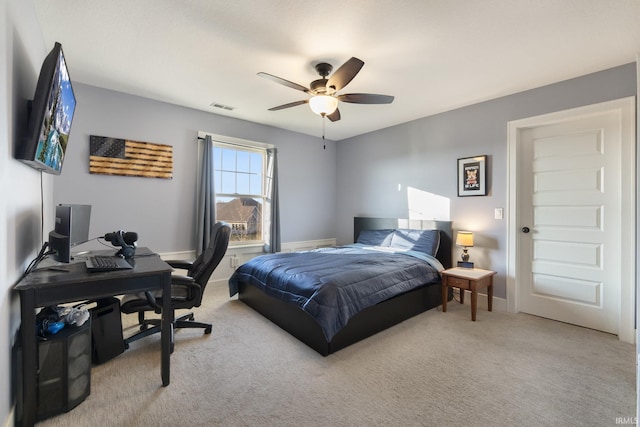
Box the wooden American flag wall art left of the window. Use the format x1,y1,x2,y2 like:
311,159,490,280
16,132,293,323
89,135,173,179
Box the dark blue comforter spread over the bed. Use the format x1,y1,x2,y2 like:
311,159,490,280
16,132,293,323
229,244,443,342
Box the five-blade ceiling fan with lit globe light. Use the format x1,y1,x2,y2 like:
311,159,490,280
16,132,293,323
258,57,393,122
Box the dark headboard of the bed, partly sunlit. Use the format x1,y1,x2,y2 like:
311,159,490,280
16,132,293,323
353,216,453,268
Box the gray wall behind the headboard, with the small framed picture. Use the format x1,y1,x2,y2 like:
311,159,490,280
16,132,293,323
336,63,636,298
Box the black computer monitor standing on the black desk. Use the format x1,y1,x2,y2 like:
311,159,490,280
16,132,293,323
49,205,91,262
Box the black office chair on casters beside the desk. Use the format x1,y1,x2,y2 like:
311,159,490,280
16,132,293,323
120,222,231,351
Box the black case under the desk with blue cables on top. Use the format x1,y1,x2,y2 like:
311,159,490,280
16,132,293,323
37,321,91,420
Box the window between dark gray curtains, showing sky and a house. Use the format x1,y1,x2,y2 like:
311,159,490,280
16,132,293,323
213,141,266,244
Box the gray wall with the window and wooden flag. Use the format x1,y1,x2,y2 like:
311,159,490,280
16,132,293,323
53,83,336,252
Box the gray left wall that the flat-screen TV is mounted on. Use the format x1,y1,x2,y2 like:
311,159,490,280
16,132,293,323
0,0,60,426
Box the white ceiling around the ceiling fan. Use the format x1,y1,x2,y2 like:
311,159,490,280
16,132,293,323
34,0,640,141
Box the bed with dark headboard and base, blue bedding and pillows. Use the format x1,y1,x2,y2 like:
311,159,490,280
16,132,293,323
229,217,452,356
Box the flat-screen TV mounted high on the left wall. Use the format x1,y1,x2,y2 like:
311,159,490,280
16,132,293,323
16,43,76,175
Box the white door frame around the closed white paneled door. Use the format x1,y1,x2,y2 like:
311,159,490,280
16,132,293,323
507,96,636,343
